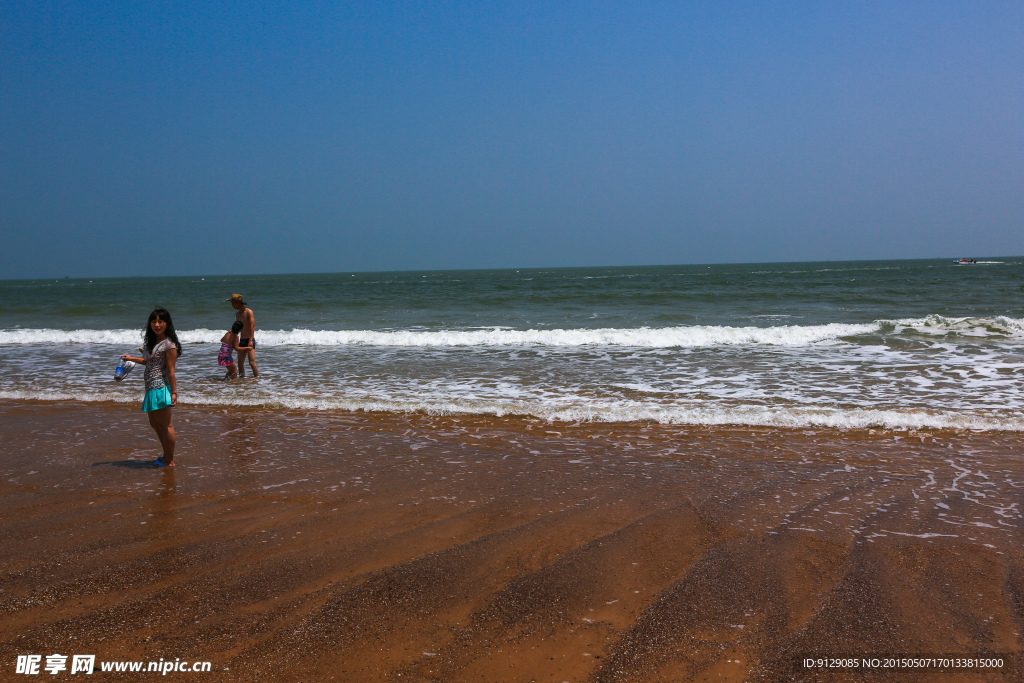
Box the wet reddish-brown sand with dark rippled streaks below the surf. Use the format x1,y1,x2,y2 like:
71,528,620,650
0,400,1024,682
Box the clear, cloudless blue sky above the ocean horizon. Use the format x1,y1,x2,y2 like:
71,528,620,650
0,0,1024,278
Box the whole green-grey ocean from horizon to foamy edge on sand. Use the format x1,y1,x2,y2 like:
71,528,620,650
0,257,1024,431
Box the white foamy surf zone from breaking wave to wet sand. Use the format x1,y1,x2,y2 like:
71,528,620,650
6,315,1024,431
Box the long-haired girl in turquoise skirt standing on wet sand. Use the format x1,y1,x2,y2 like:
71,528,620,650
121,306,181,467
